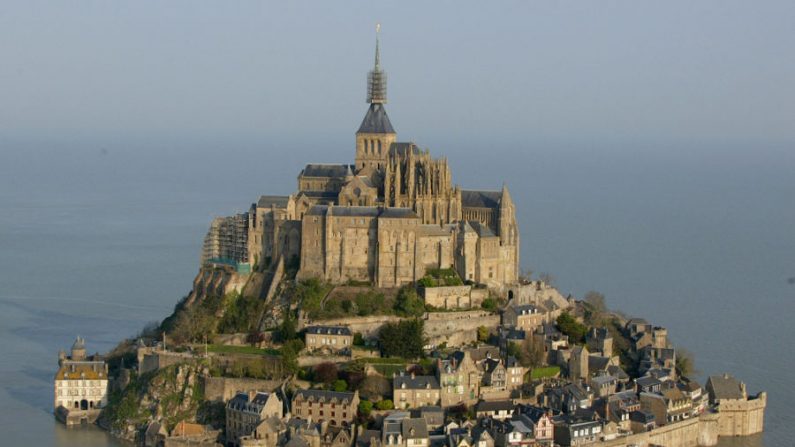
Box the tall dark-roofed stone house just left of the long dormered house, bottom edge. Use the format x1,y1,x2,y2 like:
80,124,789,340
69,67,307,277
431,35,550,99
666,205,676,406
226,392,283,446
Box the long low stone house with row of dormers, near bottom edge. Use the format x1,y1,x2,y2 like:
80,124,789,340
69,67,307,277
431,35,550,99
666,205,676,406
292,390,359,427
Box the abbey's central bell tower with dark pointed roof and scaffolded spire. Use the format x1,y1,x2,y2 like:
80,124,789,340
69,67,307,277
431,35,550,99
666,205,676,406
356,24,397,177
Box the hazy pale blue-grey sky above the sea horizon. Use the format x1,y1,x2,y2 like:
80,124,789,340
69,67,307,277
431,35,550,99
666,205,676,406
0,0,795,149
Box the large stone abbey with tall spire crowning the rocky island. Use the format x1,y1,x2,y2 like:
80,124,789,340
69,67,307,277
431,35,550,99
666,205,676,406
202,33,519,288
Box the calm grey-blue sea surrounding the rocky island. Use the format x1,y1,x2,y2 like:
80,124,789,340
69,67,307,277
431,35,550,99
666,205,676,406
0,137,795,447
